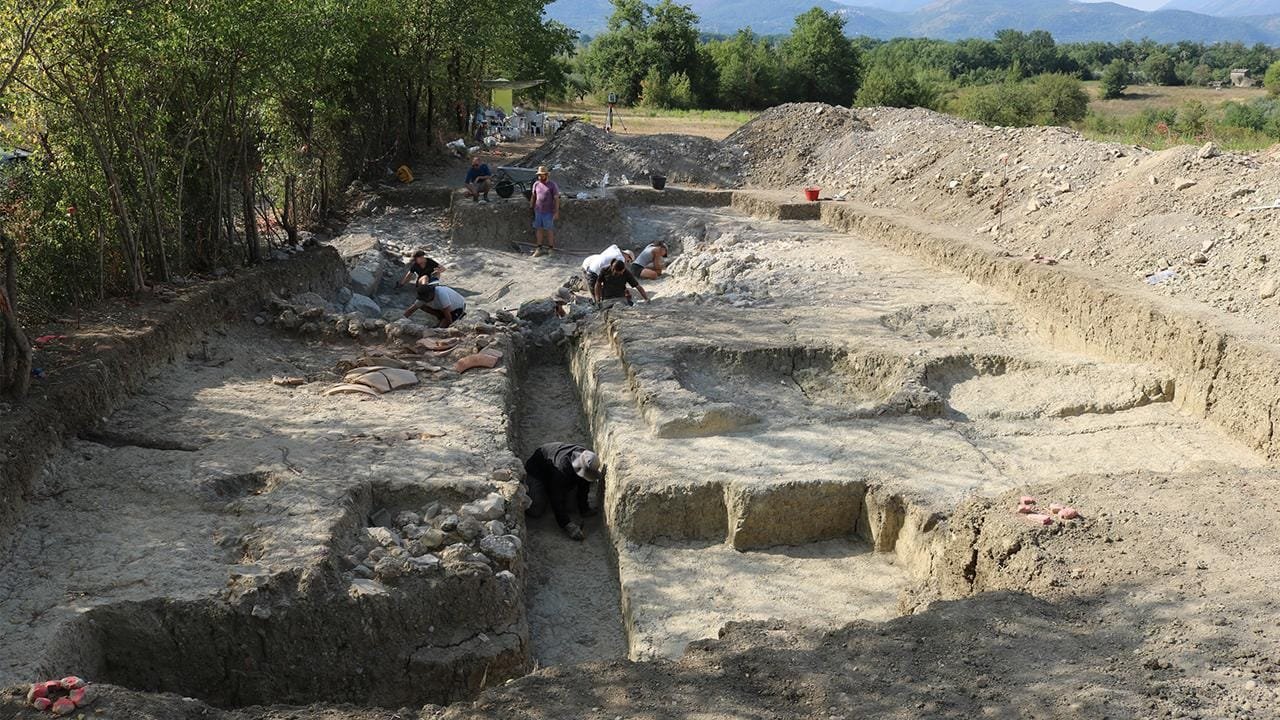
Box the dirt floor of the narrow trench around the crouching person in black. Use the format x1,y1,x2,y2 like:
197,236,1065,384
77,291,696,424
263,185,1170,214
520,364,627,667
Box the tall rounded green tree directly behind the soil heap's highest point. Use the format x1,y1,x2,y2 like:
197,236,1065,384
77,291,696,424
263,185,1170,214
780,8,861,105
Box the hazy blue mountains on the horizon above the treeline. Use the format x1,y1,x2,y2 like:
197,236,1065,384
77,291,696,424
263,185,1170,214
547,0,1280,45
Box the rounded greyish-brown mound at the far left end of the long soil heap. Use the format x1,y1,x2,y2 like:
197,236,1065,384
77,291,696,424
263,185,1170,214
722,102,869,187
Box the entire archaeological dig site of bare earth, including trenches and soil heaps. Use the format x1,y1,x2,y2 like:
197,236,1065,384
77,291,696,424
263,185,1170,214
0,104,1280,720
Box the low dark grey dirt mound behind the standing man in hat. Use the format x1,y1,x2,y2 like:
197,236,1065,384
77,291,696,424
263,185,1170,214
520,122,737,190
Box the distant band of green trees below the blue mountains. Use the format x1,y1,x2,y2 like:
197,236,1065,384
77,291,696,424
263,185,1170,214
566,0,1280,110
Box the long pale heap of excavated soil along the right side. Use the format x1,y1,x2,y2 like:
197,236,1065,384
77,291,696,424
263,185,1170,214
742,105,1280,328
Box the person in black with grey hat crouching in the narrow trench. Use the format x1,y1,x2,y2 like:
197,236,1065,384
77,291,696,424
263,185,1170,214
525,442,604,541
